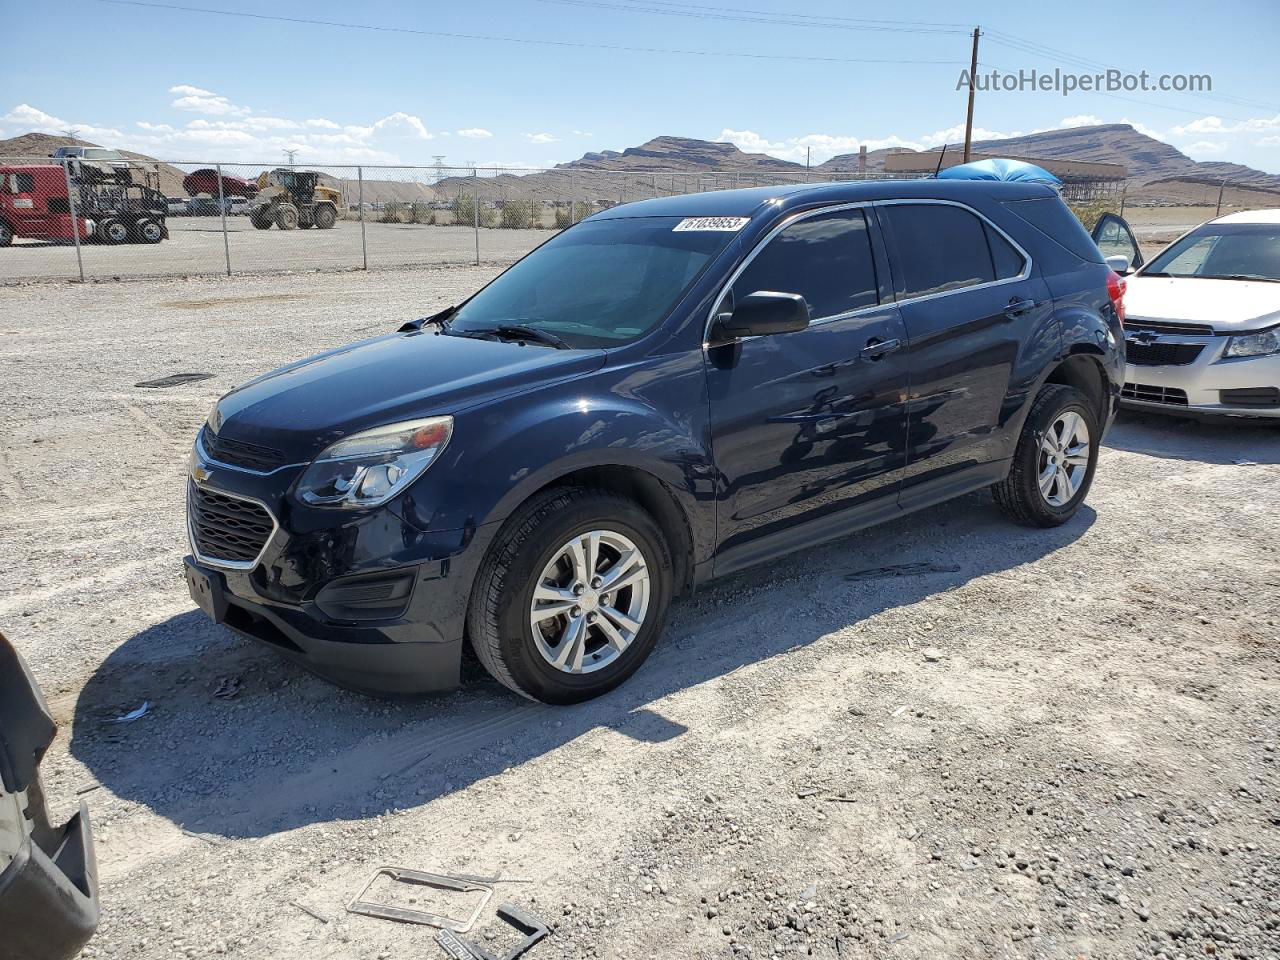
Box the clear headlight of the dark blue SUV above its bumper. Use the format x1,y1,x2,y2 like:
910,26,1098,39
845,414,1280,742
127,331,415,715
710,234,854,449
296,417,453,507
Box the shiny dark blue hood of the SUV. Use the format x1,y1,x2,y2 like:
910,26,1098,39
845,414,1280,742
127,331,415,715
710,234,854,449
211,332,604,462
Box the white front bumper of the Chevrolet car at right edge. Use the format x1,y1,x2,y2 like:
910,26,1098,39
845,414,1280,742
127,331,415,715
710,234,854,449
1120,337,1280,417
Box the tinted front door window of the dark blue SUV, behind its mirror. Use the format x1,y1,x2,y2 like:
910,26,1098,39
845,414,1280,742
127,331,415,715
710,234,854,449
733,210,879,320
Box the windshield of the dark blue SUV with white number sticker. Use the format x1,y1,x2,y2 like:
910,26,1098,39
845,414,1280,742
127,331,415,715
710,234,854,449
449,216,733,347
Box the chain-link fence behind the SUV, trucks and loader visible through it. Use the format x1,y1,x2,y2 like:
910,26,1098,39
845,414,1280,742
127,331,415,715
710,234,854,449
0,151,1280,283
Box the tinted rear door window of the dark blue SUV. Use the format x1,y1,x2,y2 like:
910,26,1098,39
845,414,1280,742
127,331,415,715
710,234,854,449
881,204,993,300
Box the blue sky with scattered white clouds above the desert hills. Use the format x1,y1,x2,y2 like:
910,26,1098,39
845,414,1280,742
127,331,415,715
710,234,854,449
0,0,1280,173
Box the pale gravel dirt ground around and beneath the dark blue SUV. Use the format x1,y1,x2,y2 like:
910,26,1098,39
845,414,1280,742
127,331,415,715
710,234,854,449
0,268,1280,960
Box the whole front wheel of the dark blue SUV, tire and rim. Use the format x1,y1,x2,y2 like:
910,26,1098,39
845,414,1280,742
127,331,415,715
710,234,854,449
467,488,672,704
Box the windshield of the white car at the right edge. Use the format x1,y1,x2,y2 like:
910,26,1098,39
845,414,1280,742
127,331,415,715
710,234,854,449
1138,224,1280,283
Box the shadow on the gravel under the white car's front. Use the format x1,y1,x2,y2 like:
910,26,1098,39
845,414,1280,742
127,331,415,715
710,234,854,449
1103,410,1280,465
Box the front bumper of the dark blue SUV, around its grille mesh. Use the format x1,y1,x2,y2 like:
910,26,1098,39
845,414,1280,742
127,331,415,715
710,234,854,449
184,462,497,694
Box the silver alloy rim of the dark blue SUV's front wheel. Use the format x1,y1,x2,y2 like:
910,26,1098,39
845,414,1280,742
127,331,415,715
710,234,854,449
529,530,650,673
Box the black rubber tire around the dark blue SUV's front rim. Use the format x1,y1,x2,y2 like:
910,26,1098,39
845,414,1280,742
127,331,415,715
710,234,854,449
467,486,672,704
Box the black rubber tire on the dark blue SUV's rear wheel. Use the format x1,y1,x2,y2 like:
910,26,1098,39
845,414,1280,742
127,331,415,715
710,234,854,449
992,384,1102,527
